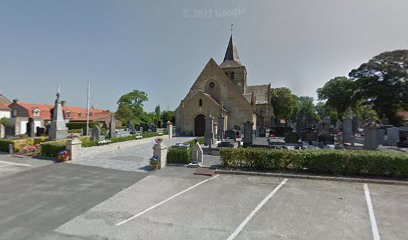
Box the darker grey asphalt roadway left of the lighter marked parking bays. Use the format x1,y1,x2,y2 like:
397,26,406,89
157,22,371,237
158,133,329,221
0,155,146,240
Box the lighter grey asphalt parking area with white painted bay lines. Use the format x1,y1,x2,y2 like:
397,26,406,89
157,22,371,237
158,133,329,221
42,167,408,240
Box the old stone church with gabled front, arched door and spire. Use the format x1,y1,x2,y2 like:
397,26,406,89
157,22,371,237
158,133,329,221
176,34,273,136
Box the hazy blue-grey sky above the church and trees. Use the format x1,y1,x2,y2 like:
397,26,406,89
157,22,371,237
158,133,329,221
0,0,408,111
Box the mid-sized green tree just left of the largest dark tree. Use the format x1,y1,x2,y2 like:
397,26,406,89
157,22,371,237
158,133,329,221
317,77,355,118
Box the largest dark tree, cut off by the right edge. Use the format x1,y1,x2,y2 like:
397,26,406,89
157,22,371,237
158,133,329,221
349,50,408,124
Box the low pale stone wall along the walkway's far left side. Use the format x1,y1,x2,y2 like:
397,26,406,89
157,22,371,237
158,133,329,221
72,135,168,161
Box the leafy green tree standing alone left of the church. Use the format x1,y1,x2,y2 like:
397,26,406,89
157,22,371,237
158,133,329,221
116,90,149,125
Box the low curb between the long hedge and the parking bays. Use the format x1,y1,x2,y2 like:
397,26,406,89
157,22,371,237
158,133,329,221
215,169,408,186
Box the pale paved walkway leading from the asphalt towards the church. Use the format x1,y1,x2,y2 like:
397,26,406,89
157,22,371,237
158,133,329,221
71,137,194,172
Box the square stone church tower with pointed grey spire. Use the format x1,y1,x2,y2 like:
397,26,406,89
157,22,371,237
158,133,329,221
220,32,247,94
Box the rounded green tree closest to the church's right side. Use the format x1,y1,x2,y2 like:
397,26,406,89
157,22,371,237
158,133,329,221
271,87,297,119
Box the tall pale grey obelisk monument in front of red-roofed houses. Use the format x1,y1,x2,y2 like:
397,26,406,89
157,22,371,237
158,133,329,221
48,89,68,140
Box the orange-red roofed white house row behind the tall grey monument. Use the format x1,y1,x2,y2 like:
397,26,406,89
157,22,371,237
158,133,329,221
8,99,111,135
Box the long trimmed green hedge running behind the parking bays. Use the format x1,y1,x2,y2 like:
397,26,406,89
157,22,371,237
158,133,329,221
221,148,408,178
